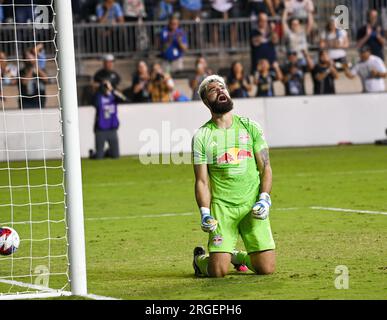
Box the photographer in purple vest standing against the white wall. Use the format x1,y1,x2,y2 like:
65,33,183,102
90,80,122,159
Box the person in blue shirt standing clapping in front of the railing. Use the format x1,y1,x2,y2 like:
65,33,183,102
161,16,188,72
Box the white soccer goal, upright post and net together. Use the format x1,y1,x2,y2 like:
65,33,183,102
0,0,88,300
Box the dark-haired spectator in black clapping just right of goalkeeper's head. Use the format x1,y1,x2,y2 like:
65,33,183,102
227,61,253,98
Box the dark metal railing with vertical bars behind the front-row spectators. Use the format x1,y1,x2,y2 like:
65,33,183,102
0,18,336,59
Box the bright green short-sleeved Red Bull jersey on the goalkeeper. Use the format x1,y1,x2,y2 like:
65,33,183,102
192,115,268,207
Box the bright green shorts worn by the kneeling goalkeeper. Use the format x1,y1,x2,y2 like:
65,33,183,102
208,203,275,253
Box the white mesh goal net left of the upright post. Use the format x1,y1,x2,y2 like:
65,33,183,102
0,0,83,299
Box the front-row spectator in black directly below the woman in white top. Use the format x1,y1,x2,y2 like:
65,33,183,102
304,49,339,94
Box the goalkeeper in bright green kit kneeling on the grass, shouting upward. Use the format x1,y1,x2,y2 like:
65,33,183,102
192,75,275,277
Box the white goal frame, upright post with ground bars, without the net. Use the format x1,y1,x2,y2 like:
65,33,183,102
0,0,87,300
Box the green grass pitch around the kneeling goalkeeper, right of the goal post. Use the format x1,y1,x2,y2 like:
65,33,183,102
0,145,387,300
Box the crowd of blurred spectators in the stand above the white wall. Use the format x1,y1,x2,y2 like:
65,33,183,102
0,0,387,108
